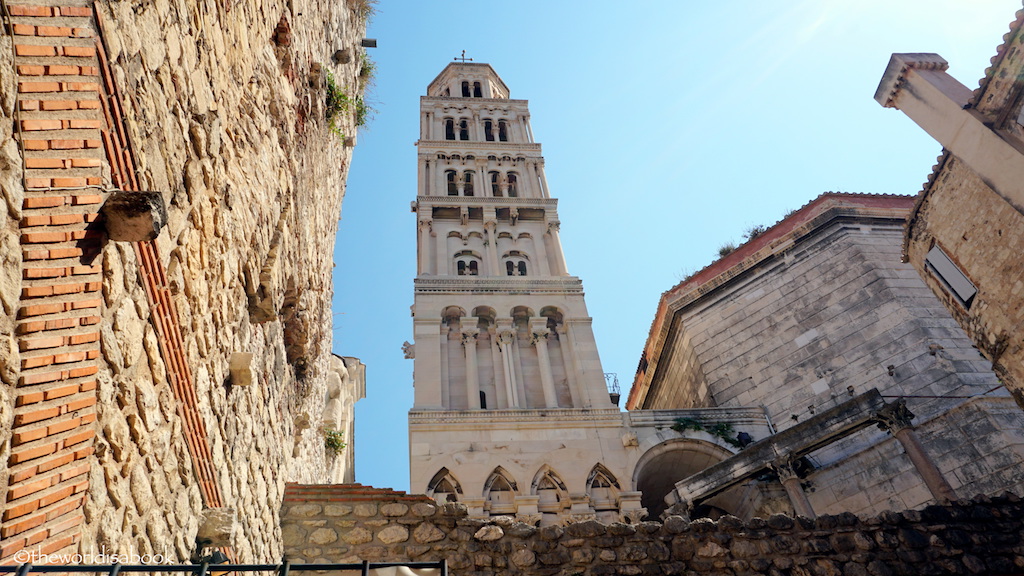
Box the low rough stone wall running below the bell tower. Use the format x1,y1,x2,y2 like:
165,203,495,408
282,479,1024,576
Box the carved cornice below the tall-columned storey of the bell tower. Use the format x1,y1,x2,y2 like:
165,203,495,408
409,408,623,426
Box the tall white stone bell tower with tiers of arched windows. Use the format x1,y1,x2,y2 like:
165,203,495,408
409,61,639,524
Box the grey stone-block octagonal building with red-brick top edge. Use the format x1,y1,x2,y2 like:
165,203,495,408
627,194,1024,517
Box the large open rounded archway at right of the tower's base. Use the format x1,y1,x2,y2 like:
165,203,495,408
633,438,733,520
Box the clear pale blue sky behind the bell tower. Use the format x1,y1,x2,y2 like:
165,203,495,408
334,0,1021,490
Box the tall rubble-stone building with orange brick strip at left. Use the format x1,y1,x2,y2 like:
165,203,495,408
0,0,369,564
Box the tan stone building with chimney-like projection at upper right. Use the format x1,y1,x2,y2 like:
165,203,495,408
874,11,1024,407
